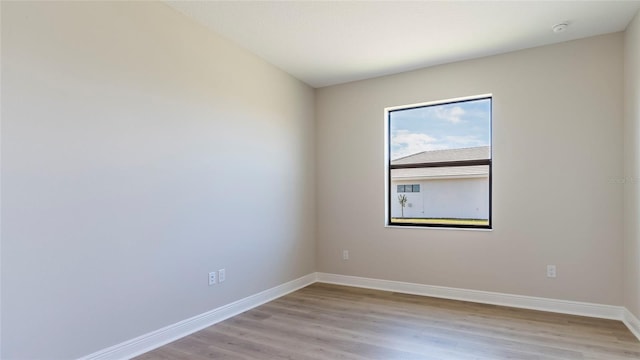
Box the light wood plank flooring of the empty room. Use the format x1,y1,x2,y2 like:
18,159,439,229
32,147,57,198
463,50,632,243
136,283,640,360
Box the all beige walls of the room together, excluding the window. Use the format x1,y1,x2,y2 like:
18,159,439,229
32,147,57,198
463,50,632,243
0,2,640,359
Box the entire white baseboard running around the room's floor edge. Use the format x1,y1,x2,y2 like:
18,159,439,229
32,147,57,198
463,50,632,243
79,273,640,360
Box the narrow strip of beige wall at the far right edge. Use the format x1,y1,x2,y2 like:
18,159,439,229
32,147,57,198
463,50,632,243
624,9,640,318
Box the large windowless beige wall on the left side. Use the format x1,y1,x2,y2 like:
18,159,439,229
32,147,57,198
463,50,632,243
0,2,315,359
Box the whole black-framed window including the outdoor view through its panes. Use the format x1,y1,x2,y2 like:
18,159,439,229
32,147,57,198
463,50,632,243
385,95,492,229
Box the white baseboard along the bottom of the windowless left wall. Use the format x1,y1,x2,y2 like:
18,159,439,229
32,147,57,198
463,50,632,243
80,273,316,360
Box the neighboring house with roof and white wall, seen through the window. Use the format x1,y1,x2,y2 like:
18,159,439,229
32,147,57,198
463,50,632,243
391,146,491,219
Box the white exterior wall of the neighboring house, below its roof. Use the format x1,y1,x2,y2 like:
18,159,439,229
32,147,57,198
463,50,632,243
391,177,489,219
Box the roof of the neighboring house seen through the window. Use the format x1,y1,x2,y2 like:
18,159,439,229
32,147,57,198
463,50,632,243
391,146,491,181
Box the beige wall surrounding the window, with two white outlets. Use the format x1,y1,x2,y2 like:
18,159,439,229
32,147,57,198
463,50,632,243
316,33,623,305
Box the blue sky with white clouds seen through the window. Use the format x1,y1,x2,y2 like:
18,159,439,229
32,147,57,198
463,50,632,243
389,99,491,160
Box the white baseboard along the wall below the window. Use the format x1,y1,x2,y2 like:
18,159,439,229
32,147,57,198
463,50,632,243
318,273,624,320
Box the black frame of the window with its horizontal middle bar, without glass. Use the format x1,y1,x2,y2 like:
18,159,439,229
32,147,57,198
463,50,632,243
385,94,493,230
